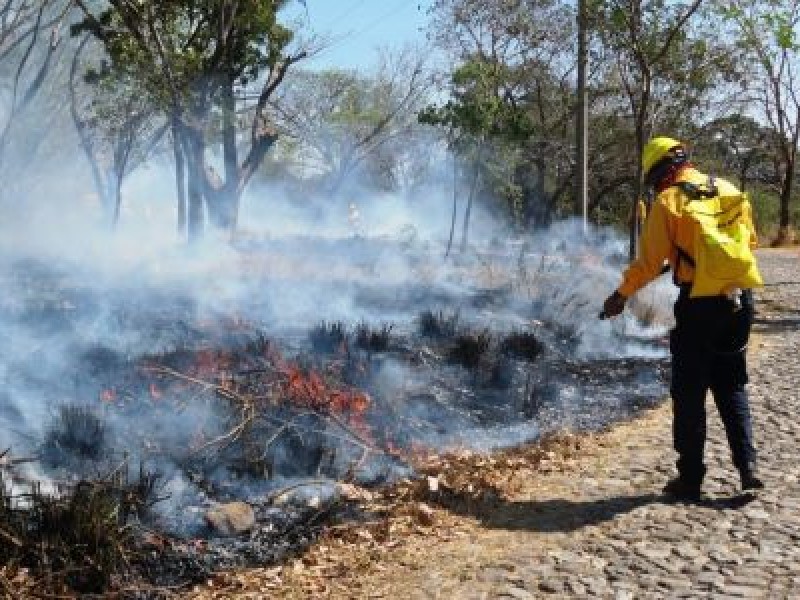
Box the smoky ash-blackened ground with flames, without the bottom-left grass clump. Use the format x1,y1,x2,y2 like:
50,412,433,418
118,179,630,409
0,231,669,596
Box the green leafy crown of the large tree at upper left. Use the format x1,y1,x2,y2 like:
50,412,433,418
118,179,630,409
72,0,292,109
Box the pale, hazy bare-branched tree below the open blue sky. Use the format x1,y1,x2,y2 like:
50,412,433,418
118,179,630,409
274,48,432,194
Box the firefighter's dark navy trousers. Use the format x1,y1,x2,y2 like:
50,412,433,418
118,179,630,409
670,289,756,483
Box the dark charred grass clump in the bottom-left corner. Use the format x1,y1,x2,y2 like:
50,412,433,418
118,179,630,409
0,462,162,597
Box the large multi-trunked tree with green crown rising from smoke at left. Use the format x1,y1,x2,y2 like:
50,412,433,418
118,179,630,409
75,0,306,239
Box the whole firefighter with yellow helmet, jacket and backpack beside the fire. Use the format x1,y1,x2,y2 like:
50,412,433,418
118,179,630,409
603,137,764,500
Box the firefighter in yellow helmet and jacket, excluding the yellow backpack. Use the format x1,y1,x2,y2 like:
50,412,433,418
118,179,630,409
603,137,764,500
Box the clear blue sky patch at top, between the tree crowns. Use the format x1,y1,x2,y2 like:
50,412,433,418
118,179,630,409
284,0,432,70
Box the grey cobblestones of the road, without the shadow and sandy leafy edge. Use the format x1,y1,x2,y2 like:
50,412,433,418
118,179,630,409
462,251,800,599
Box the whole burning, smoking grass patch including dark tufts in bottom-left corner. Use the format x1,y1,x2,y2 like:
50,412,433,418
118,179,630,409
0,229,664,598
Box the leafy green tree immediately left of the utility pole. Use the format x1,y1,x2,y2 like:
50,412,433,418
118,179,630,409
421,0,575,227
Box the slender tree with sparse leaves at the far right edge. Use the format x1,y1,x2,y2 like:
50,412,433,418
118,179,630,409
724,0,800,244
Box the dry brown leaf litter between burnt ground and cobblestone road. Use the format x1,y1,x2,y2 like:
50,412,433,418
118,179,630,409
192,433,604,600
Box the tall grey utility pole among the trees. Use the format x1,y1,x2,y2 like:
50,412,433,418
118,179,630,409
575,0,589,233
